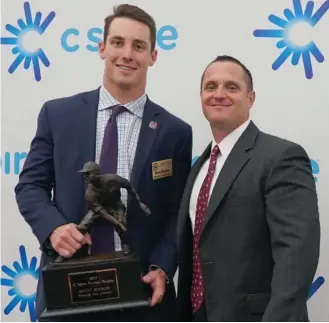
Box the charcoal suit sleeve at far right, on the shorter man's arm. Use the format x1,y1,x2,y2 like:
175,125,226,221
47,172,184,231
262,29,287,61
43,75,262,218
263,144,320,322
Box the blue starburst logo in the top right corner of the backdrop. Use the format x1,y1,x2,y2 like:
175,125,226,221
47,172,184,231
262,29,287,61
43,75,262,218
253,0,329,79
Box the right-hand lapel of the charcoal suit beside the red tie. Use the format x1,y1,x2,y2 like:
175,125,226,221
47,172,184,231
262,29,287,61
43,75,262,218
203,122,258,235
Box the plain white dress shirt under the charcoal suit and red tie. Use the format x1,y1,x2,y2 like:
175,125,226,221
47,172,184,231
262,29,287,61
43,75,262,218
190,119,250,232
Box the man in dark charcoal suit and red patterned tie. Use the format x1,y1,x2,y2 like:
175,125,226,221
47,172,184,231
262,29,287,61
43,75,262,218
177,56,320,322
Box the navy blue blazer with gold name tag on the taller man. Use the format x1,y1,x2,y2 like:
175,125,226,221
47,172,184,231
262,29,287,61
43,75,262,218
15,89,192,322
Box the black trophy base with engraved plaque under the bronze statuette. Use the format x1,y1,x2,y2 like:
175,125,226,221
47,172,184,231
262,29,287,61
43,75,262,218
41,252,149,319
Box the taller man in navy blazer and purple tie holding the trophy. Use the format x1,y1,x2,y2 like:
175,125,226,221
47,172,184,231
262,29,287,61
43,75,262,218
15,4,192,321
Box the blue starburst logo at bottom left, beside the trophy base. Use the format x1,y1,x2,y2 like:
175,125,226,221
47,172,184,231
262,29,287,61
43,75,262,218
1,246,39,322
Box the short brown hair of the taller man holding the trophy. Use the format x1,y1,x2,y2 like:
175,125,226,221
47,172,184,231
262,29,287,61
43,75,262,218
104,4,156,51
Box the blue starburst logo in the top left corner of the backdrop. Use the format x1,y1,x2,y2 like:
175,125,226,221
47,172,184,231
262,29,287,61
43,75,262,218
1,2,55,82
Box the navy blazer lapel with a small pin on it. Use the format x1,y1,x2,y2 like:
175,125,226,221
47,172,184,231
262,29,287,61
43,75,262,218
130,98,161,191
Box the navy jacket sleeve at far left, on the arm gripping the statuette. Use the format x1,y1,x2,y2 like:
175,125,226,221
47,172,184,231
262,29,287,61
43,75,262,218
15,103,67,251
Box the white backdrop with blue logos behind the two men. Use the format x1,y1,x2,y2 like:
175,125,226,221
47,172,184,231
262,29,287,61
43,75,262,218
1,0,329,321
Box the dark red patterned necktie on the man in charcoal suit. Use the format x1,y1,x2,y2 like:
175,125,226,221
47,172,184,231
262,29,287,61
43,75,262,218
191,145,219,313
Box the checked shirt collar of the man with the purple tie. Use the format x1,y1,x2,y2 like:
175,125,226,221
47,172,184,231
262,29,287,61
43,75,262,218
98,85,147,118
